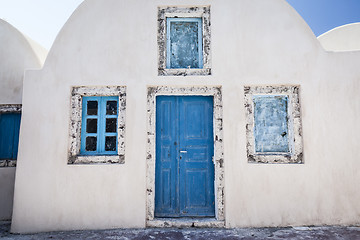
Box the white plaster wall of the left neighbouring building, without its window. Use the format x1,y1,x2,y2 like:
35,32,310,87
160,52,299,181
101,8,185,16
0,19,47,220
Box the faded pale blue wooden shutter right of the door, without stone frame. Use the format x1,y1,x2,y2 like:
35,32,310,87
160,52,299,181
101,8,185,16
253,95,289,153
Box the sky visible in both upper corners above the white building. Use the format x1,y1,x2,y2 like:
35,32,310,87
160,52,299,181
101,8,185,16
0,0,360,49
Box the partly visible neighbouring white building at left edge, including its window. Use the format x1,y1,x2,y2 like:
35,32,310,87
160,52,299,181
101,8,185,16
0,19,47,220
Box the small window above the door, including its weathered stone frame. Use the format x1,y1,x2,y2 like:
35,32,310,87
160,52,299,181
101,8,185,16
158,6,211,76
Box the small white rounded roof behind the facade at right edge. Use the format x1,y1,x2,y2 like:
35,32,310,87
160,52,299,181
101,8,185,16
318,23,360,51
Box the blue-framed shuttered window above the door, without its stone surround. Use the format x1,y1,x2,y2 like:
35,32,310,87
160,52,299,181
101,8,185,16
166,18,203,68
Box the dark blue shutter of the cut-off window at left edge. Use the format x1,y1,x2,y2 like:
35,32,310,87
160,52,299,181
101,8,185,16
0,113,21,160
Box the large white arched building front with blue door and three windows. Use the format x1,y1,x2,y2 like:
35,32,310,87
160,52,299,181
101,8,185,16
12,0,360,233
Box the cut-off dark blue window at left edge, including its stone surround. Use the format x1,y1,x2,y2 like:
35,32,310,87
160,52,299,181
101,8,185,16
0,104,21,167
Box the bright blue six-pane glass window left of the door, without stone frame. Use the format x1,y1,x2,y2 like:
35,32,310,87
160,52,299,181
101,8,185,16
80,96,119,155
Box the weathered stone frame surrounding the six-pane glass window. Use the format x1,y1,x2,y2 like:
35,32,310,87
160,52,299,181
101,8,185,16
68,86,126,164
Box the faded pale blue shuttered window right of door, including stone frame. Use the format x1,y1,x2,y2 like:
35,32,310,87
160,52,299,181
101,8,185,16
244,86,303,163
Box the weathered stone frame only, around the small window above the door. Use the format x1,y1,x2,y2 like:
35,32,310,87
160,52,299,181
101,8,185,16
158,6,211,76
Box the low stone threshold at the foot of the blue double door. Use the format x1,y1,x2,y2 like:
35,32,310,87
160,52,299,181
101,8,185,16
146,218,225,228
